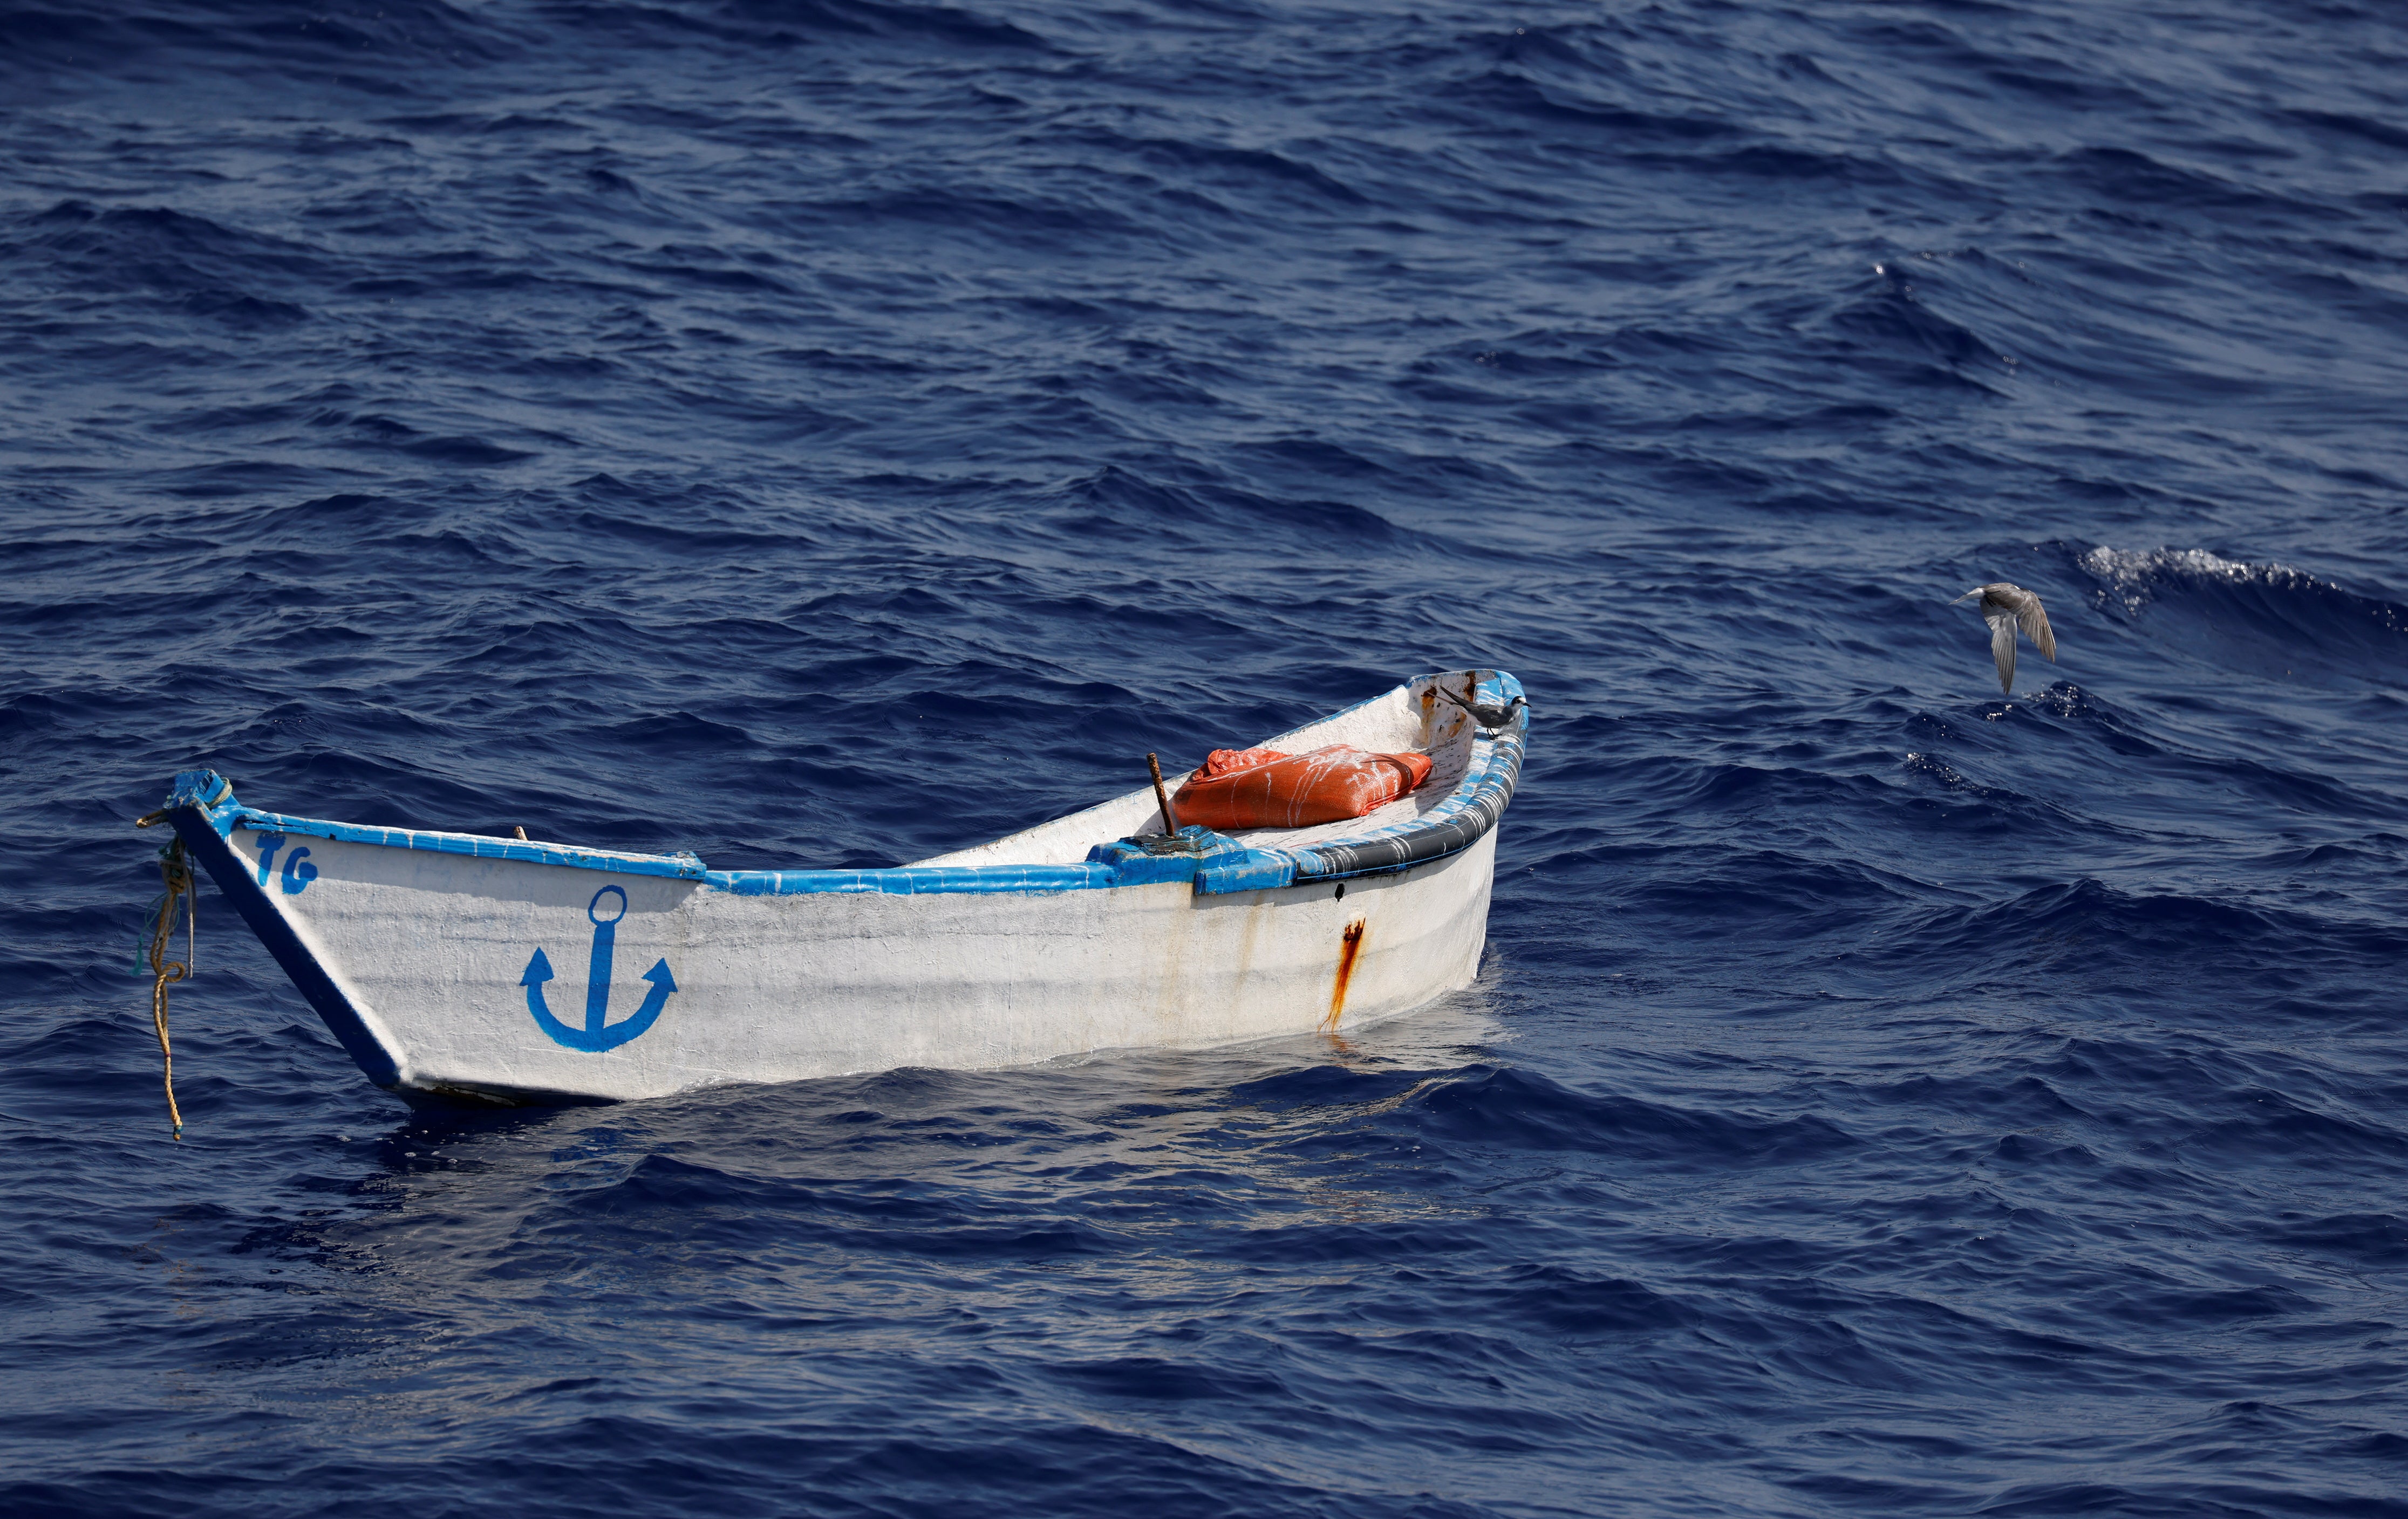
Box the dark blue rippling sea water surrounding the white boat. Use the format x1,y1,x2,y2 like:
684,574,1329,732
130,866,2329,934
0,0,2408,1519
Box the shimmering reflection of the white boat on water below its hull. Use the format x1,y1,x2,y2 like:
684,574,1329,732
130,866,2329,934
313,987,1505,1281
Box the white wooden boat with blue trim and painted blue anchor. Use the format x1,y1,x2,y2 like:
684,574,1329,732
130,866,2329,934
166,669,1529,1103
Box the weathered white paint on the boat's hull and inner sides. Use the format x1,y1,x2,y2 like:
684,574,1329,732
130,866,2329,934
165,681,1496,1100
